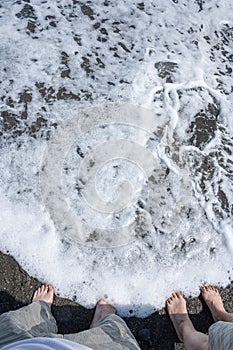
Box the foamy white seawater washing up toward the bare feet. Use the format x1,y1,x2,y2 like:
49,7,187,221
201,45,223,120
0,0,233,317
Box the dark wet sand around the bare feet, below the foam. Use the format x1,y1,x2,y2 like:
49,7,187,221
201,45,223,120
0,253,233,350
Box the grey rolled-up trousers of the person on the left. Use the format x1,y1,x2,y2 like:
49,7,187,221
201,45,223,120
0,301,140,350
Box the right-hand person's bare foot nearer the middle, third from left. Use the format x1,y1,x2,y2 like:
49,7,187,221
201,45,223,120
166,292,194,341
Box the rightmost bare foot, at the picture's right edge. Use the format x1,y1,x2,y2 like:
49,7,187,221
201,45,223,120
201,286,233,322
